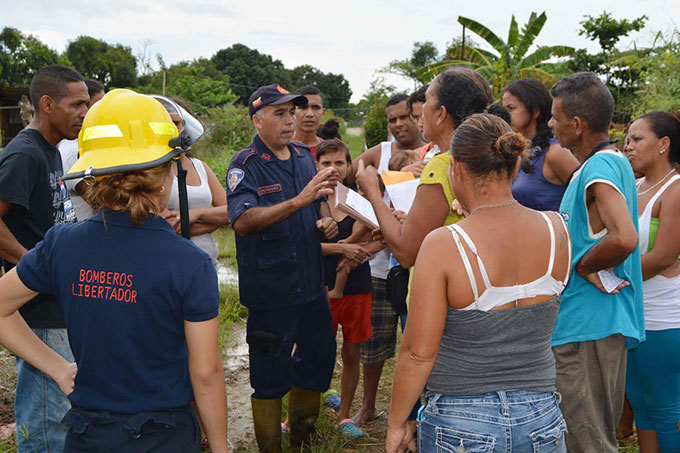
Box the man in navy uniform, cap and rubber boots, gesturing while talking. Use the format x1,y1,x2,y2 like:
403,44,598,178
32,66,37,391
226,85,337,452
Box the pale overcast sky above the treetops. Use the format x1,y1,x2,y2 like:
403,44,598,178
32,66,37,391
5,0,680,101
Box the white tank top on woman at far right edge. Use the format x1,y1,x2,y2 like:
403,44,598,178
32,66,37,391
637,175,680,330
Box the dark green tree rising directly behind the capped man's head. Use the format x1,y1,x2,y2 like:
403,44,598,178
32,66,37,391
210,44,290,105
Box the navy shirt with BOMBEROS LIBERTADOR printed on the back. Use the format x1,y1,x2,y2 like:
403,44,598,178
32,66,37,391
17,210,219,413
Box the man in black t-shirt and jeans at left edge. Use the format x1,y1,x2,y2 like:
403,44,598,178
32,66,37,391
0,65,90,453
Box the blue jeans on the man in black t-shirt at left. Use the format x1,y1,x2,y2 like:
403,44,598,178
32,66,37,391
14,329,73,453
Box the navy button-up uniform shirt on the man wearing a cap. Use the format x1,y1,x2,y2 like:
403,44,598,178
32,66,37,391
227,136,325,308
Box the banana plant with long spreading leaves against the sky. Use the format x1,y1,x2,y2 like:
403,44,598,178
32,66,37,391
417,12,574,98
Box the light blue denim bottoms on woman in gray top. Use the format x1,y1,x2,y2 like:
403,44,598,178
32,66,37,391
418,390,567,453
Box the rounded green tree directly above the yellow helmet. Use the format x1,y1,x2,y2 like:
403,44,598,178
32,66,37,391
66,36,137,88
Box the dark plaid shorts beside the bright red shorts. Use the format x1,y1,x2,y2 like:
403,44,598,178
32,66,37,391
360,277,399,365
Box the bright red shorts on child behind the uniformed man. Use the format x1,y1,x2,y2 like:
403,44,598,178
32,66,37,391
330,293,373,343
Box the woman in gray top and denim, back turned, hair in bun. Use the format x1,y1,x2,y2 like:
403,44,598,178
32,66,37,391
386,114,571,453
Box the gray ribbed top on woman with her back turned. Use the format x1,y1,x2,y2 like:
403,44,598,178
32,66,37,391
426,296,560,396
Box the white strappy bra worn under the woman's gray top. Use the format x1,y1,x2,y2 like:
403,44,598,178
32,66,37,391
447,212,571,311
